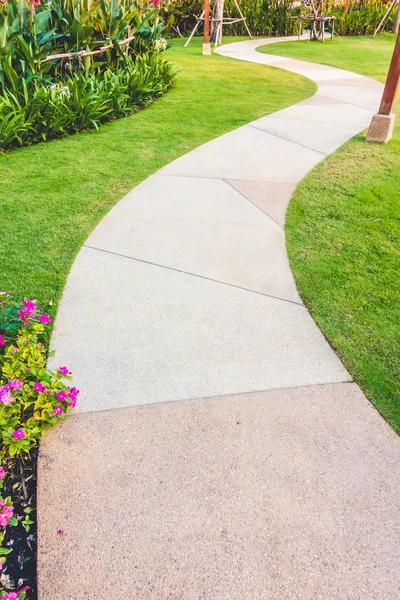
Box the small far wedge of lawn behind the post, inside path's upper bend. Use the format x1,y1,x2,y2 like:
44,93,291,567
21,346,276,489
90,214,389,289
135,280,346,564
258,33,396,81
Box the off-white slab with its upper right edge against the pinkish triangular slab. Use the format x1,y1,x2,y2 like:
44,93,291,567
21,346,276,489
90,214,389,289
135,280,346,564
86,175,301,303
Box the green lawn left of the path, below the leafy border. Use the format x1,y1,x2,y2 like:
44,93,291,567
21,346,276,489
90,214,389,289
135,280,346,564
0,38,315,314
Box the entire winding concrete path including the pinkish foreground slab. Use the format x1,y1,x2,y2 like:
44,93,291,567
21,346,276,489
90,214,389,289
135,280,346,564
39,39,400,600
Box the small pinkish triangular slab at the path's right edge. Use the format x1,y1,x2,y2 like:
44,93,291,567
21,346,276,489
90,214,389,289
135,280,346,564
228,179,296,227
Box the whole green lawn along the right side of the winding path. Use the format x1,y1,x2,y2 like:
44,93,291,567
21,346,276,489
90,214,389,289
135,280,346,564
265,34,400,433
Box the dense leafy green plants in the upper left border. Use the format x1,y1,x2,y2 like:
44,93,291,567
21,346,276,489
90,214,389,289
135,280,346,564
0,0,174,149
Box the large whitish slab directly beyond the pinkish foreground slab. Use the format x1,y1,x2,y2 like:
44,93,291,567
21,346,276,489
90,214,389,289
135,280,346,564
50,248,350,411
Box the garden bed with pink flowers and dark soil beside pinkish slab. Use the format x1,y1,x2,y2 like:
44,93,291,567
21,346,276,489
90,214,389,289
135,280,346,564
0,292,79,600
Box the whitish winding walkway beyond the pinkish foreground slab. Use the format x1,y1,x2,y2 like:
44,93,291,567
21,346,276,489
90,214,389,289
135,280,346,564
44,40,388,412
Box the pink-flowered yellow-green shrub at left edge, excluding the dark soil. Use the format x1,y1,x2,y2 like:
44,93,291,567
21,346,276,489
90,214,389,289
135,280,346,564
0,292,79,600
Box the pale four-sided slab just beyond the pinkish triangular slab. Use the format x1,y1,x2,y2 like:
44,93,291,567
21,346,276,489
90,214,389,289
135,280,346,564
159,125,324,183
